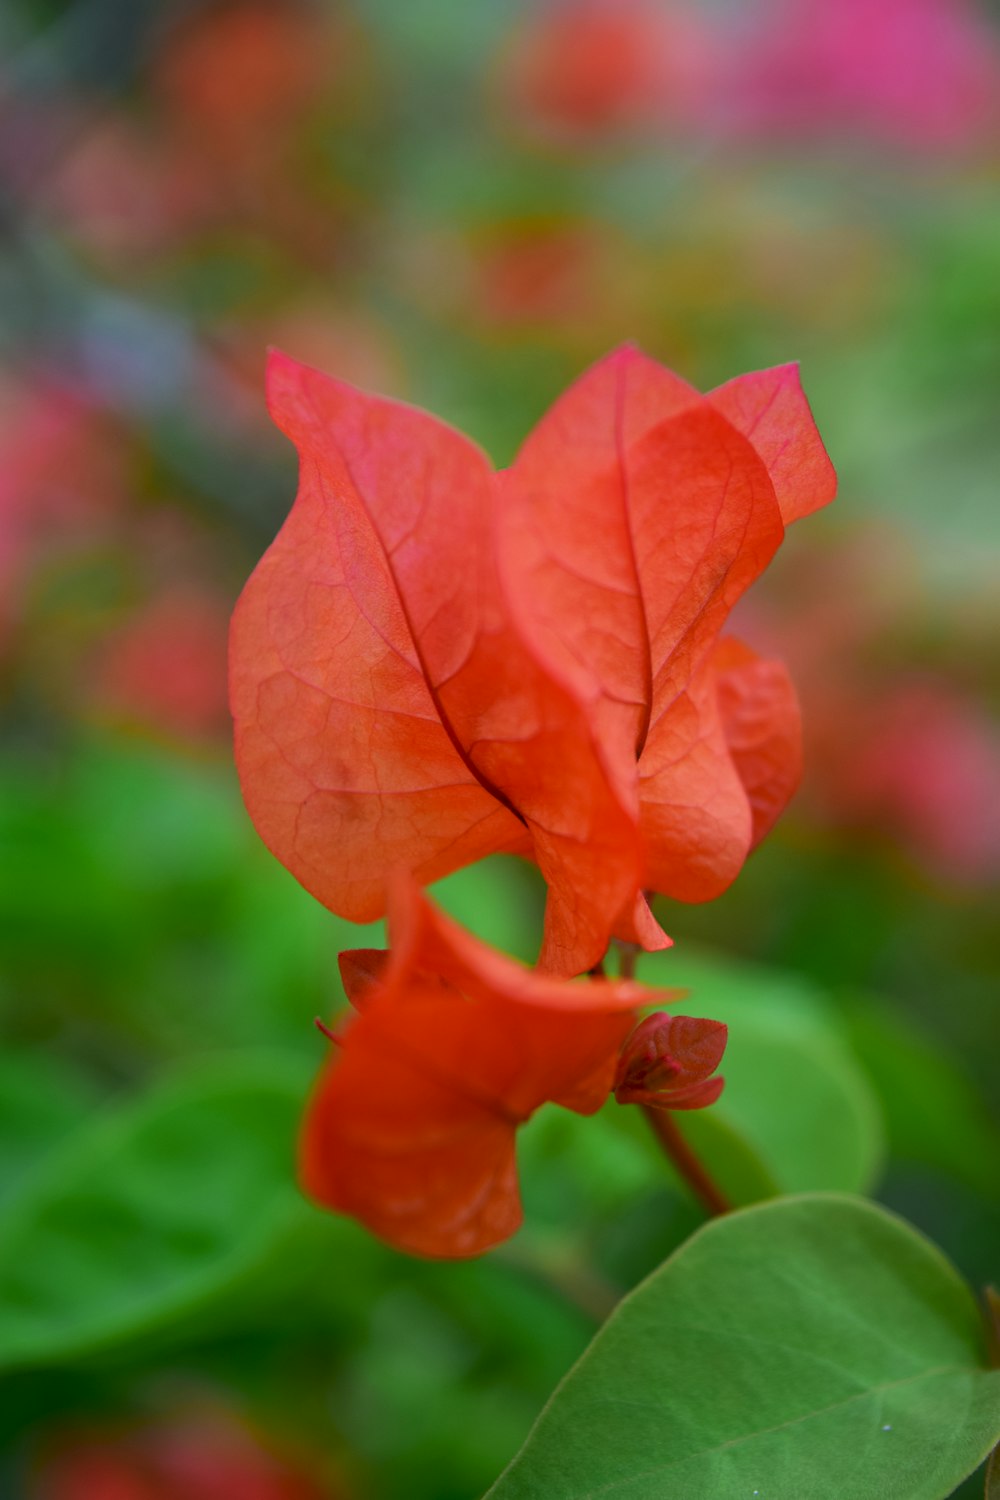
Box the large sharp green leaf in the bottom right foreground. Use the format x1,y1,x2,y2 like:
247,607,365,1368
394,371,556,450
489,1194,1000,1500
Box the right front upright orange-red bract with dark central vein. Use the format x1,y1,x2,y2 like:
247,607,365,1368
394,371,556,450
501,348,784,912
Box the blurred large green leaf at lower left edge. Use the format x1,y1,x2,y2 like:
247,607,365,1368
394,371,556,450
0,1058,306,1365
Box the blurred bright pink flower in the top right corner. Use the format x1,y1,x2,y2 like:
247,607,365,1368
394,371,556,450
728,0,1000,147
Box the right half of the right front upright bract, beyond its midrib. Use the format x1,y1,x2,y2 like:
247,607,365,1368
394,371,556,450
620,405,783,902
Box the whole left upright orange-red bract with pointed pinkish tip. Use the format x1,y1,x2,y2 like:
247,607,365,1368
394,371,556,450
241,356,650,974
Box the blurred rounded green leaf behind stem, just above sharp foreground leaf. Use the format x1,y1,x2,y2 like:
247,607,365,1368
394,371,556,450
640,953,883,1206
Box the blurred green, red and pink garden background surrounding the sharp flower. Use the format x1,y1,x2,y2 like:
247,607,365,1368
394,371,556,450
0,0,1000,1500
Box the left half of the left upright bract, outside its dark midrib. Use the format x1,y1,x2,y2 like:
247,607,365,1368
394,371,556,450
229,356,523,921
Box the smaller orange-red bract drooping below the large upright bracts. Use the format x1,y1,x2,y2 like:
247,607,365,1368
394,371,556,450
301,881,726,1257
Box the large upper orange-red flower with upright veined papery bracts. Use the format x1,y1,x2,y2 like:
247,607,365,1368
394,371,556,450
231,348,835,974
